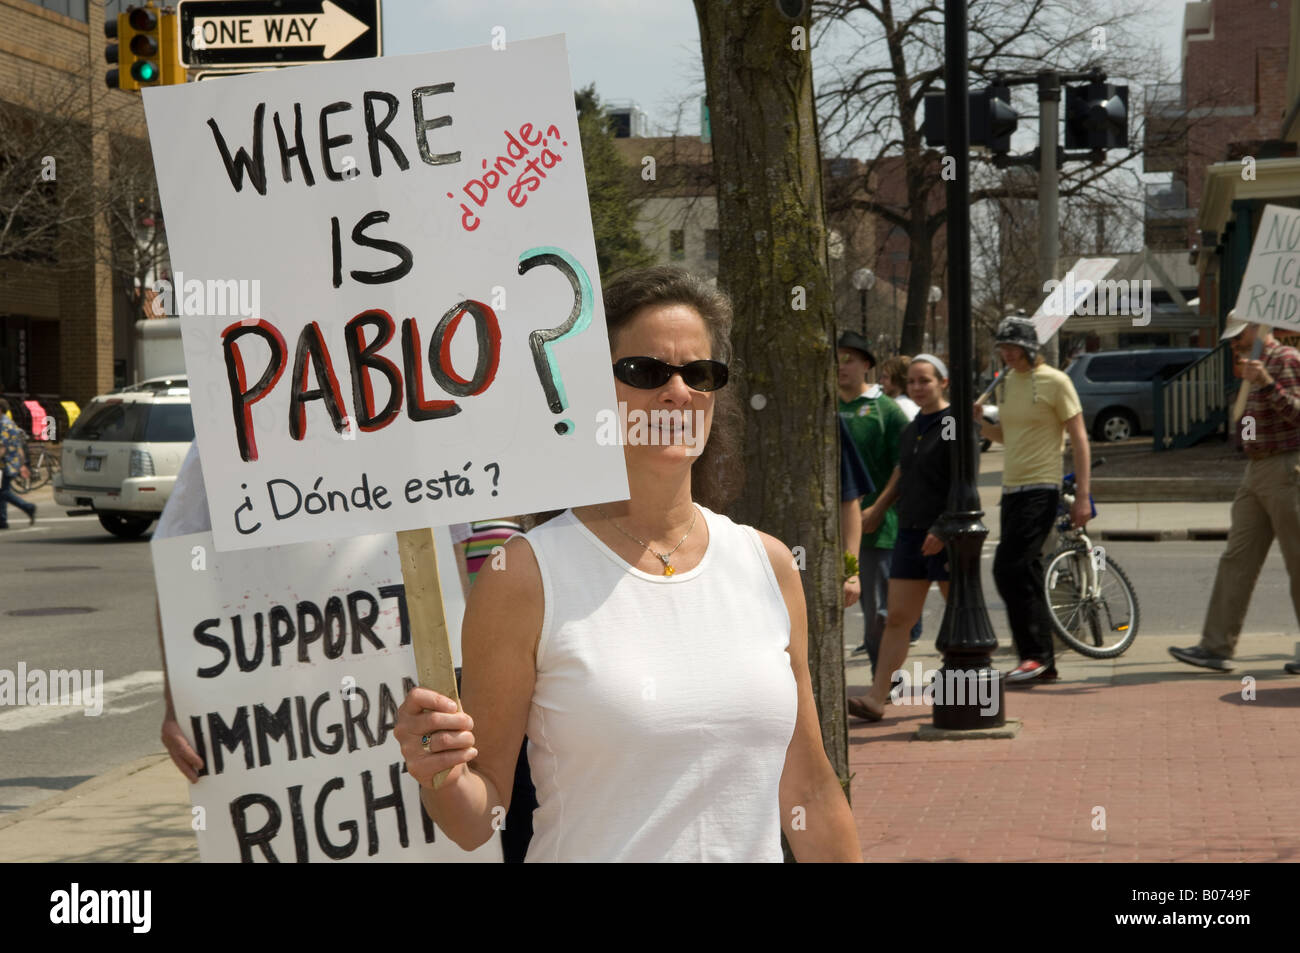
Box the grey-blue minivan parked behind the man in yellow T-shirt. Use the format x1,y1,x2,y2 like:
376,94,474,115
1066,347,1210,441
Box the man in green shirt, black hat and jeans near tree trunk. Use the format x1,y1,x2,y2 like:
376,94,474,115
836,332,919,675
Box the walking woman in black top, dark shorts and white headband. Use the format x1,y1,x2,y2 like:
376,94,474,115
849,354,972,722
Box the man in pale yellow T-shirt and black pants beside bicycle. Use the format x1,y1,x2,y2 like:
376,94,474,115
974,316,1092,685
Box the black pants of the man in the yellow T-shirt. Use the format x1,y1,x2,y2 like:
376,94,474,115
993,490,1061,666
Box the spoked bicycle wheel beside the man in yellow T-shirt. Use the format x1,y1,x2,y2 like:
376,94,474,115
1045,549,1140,658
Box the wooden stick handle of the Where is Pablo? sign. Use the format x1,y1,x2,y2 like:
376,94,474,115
398,529,460,790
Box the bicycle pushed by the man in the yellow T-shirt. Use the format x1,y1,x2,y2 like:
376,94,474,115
1044,459,1141,658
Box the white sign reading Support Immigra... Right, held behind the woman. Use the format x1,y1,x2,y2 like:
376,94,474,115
152,533,501,862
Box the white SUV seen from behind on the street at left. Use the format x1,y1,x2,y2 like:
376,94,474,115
53,378,194,540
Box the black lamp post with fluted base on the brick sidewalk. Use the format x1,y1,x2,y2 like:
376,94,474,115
933,0,1006,729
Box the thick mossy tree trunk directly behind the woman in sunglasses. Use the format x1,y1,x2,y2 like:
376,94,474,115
696,0,849,792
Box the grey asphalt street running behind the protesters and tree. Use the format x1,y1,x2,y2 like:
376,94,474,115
0,498,1296,815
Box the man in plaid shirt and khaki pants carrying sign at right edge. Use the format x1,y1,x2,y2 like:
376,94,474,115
1169,312,1300,675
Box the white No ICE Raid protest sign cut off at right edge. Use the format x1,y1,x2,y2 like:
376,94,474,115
1236,205,1300,332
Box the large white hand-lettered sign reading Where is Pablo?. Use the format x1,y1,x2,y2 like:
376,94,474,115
144,36,628,550
